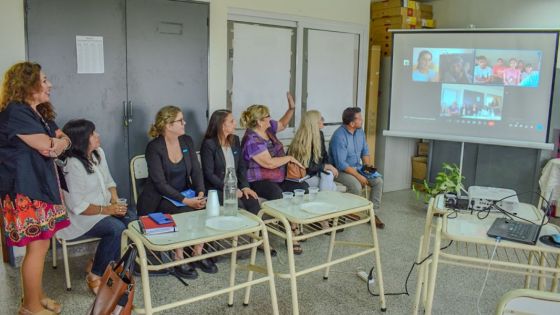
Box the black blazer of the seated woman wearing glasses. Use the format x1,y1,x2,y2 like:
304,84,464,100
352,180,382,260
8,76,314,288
137,135,204,213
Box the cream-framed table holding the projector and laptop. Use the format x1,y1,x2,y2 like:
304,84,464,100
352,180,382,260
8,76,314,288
413,196,560,314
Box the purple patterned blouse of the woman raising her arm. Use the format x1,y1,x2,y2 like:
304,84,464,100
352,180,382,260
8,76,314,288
242,120,286,183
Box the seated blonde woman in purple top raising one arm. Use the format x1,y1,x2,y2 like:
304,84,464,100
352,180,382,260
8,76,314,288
241,93,309,255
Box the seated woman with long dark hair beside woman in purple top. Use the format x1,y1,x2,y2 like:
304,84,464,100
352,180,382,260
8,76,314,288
200,109,261,214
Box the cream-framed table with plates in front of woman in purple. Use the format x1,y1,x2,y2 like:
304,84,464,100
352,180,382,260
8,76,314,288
255,191,386,315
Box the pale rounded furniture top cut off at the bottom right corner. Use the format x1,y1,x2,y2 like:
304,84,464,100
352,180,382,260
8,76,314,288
495,289,560,315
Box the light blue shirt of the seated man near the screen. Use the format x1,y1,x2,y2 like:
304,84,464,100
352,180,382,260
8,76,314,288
329,125,369,171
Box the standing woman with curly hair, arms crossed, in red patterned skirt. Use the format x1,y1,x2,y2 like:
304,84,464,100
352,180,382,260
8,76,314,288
0,62,71,315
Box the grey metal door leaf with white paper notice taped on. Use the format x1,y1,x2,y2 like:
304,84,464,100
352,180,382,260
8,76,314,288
26,0,130,196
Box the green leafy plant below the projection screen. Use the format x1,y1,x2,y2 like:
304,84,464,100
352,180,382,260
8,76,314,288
412,163,465,202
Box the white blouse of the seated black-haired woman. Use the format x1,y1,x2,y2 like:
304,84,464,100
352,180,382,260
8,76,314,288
57,148,117,240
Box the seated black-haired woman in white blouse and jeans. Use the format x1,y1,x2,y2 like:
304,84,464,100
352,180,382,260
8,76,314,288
57,119,136,294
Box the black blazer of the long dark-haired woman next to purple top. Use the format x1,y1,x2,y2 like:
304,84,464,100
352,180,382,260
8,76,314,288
200,135,249,190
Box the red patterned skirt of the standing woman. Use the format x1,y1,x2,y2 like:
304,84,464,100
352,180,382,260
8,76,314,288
2,194,70,247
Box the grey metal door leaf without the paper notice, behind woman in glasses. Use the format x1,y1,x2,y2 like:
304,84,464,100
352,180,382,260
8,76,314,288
126,0,208,156
